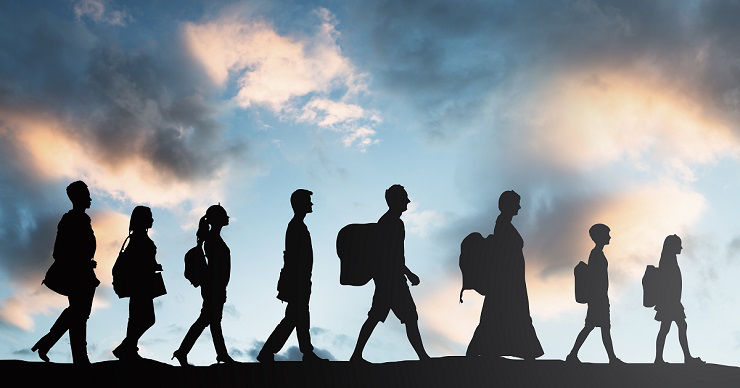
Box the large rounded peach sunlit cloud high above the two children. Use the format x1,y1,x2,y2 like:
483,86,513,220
514,69,740,181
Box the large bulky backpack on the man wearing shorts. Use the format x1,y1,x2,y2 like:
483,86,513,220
337,223,380,286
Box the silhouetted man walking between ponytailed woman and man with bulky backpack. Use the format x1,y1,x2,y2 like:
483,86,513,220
257,189,326,362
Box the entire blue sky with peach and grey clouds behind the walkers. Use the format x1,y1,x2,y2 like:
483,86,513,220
0,0,740,364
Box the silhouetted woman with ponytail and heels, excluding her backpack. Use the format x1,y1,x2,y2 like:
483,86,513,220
172,205,236,366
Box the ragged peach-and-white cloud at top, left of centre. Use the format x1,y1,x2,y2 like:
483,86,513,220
183,7,380,149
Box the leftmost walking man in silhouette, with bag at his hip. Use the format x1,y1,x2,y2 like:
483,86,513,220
31,181,100,365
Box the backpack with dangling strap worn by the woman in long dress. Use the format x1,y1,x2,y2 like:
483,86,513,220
459,232,493,303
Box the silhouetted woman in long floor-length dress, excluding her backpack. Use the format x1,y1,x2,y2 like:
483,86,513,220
466,191,544,360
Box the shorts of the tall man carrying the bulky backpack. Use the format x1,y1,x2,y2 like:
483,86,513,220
367,279,419,323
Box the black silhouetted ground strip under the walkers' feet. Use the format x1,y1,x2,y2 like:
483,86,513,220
0,357,740,388
